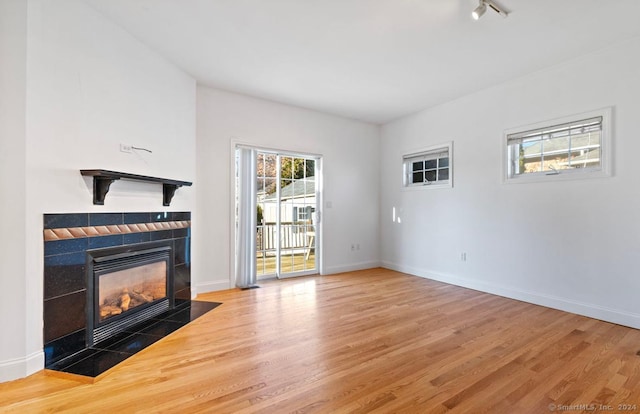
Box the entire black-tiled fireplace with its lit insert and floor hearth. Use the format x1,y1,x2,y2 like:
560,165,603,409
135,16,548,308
43,211,219,378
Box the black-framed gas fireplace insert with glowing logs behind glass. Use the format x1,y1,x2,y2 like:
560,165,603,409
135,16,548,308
86,242,174,347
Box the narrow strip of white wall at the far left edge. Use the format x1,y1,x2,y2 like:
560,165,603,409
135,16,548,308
0,0,29,382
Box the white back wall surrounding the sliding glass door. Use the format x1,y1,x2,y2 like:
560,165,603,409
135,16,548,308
193,87,379,292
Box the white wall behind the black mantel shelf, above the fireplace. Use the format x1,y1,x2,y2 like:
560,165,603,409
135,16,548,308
0,0,196,379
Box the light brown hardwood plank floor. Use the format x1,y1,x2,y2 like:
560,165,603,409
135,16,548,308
0,269,640,413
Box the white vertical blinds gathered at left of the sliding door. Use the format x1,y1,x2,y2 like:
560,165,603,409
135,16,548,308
236,148,257,289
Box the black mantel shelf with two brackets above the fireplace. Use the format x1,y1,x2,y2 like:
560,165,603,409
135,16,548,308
80,170,193,206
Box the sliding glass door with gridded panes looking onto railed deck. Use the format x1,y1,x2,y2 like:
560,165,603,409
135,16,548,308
256,151,320,279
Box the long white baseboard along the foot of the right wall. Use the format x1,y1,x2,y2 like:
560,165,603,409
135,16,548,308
382,261,640,329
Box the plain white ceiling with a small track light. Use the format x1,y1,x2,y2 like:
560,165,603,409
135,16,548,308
84,0,640,124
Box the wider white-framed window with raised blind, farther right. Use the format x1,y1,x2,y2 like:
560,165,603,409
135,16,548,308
505,108,611,181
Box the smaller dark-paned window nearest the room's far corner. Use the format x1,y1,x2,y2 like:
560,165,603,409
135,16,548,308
402,143,453,188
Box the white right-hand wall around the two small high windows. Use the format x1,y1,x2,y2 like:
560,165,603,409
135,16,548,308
381,38,640,328
